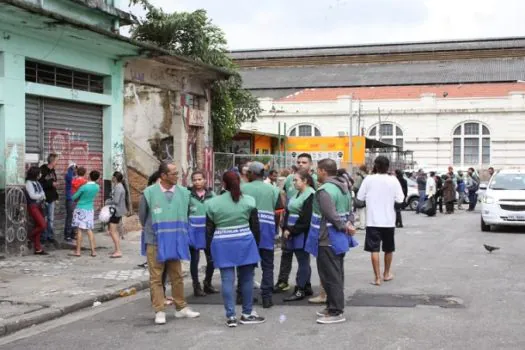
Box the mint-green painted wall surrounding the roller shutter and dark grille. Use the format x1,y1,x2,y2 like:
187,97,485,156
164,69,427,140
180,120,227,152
0,1,137,188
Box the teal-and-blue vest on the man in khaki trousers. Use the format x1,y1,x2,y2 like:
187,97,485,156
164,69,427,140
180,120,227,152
144,184,190,262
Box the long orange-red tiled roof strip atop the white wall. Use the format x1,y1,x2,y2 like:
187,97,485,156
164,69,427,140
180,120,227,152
279,83,525,102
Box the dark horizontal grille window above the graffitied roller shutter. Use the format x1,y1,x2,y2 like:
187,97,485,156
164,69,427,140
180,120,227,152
25,60,104,94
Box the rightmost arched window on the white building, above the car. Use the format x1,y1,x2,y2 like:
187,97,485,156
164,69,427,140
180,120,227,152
452,122,490,165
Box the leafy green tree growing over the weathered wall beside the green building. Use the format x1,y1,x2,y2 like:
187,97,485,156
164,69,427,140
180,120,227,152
131,0,261,151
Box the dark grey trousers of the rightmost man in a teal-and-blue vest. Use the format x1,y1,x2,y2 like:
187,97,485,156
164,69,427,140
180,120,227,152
317,247,345,316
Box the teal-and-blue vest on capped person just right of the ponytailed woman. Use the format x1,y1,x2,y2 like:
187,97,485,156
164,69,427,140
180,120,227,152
241,180,279,250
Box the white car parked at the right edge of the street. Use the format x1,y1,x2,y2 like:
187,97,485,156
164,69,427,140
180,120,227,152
480,169,525,231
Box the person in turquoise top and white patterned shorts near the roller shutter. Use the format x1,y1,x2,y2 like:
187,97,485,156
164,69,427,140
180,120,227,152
71,170,100,257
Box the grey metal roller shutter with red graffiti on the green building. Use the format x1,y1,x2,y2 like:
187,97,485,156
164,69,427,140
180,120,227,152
42,99,104,232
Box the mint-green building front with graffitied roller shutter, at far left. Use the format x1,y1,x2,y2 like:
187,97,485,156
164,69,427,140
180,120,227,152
0,0,144,253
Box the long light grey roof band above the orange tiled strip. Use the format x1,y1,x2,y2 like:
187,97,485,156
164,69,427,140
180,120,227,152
240,57,525,90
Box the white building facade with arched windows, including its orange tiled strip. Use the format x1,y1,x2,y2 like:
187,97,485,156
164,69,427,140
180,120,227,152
248,83,525,169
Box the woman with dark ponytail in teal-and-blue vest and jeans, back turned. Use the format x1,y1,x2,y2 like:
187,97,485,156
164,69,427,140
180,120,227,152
206,171,265,327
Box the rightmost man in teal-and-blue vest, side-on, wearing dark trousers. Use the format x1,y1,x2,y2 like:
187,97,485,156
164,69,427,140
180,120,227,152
314,159,355,324
